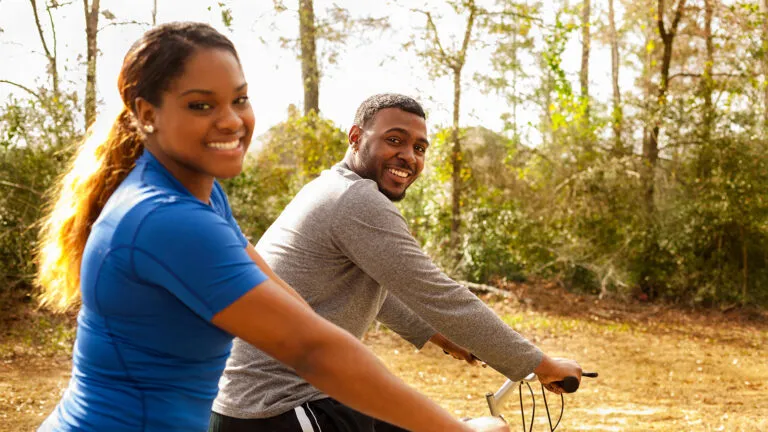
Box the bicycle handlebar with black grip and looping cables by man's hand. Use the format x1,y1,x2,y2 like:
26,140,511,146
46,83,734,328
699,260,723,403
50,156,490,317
485,372,598,432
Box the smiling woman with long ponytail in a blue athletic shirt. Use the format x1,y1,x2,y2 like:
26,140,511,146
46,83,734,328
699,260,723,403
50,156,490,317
38,23,504,431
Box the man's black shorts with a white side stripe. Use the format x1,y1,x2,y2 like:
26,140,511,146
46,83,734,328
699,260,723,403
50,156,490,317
208,398,405,432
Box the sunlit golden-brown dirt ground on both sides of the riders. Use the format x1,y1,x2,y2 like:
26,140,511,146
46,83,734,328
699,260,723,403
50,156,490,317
0,284,768,431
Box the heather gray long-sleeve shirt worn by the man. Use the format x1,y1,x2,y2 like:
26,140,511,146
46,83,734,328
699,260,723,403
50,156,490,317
213,163,542,418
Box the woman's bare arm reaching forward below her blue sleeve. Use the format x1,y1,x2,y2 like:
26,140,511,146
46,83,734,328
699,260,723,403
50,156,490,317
212,275,472,432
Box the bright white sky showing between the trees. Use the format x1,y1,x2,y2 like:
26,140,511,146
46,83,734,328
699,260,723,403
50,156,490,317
0,0,611,147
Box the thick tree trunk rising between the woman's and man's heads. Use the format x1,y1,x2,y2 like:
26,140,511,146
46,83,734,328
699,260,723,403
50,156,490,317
299,0,320,115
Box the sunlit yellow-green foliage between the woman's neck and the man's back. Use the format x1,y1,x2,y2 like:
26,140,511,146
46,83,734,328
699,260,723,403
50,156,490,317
224,106,347,241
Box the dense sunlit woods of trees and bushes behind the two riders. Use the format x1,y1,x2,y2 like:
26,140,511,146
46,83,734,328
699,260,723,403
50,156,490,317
0,0,768,306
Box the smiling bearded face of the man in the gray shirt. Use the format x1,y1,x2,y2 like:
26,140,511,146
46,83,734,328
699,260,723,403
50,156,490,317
349,108,429,201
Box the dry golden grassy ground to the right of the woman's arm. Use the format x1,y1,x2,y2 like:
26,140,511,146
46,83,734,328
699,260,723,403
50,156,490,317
367,286,768,431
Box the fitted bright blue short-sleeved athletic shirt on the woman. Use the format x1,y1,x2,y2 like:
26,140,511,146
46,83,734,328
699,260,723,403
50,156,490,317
40,151,267,432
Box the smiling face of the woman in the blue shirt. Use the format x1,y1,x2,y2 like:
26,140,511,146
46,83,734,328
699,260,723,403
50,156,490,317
136,48,254,195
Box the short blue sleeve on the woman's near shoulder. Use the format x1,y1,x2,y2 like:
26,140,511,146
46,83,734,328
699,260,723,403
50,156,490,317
131,201,267,321
